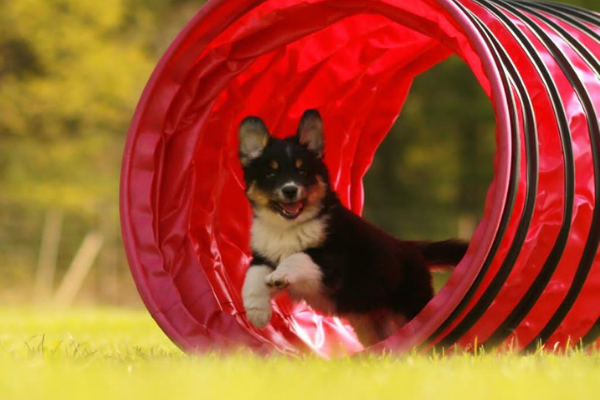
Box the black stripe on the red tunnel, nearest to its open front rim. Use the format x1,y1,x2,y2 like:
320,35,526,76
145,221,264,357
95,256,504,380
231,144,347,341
420,6,521,347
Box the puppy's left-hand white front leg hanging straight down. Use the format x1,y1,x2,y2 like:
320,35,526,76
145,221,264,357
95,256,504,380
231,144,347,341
242,265,273,328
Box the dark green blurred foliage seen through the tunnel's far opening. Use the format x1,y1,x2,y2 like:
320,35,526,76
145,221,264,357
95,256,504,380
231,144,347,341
365,57,495,239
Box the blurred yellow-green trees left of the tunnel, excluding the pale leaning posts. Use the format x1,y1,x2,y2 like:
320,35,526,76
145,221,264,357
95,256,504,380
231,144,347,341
0,0,202,300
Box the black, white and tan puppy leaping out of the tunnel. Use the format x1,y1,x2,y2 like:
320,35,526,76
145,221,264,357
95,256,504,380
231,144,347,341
238,110,468,346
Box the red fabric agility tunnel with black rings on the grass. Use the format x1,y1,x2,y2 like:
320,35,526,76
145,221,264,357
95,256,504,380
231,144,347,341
121,0,600,356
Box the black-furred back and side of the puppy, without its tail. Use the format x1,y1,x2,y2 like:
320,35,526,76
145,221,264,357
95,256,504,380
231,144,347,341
305,197,433,318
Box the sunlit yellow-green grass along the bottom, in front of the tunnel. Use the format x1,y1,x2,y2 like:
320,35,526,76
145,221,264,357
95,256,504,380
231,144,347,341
0,309,600,400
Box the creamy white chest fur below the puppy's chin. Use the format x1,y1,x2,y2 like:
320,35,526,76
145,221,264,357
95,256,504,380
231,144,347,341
250,215,326,264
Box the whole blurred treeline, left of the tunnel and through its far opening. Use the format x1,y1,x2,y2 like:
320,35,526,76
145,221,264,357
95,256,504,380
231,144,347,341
0,0,600,303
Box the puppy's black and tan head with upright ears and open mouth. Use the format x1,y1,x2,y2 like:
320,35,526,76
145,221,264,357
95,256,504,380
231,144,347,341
239,110,329,224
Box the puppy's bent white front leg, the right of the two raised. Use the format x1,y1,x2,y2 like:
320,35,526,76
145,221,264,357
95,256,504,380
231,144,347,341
265,253,323,304
